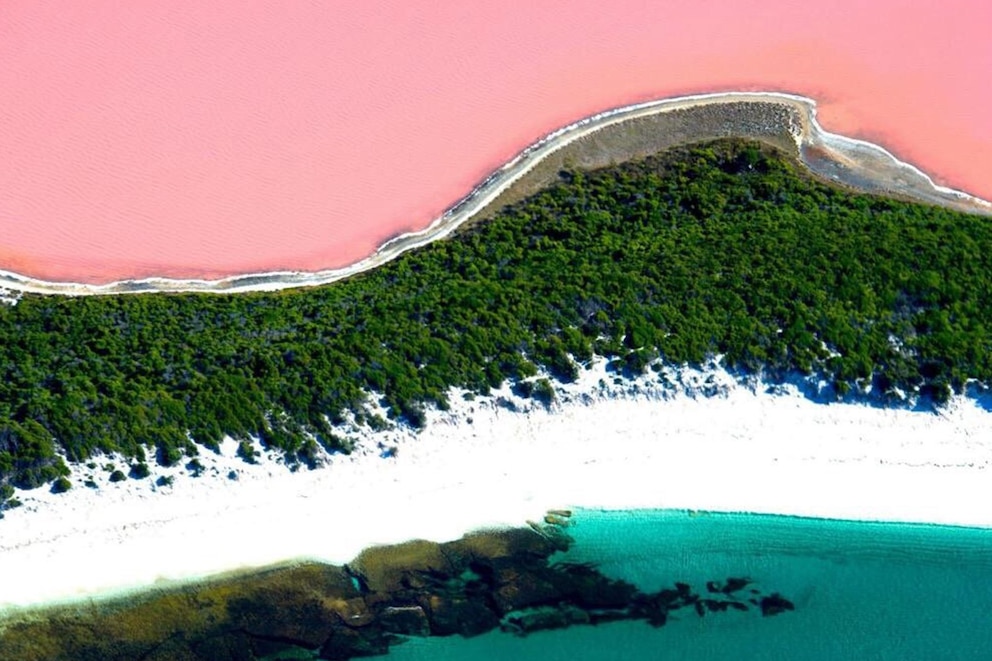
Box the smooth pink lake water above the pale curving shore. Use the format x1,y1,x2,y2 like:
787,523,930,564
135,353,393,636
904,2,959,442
0,0,992,282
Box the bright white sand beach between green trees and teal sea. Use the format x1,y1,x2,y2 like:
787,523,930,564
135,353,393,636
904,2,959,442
0,361,992,610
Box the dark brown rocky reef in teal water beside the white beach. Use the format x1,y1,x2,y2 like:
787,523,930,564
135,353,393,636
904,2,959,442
0,512,793,661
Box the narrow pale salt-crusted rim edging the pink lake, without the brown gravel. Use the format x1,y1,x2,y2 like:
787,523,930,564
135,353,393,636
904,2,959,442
0,92,992,304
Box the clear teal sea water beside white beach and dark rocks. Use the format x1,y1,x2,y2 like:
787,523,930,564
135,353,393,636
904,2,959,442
389,510,992,661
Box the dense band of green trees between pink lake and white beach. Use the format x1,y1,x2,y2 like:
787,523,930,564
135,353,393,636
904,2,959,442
0,141,992,488
